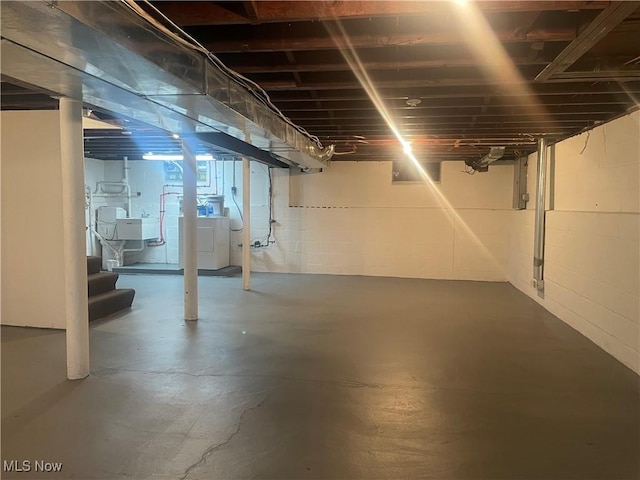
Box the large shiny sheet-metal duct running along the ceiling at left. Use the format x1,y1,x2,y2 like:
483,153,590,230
0,1,333,168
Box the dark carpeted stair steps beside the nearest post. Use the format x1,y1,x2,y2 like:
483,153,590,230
87,257,136,321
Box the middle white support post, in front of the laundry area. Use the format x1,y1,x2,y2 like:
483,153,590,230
182,140,198,320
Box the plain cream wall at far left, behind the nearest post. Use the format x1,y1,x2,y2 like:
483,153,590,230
1,111,66,328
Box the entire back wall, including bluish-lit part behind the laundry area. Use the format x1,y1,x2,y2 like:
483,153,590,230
104,156,513,281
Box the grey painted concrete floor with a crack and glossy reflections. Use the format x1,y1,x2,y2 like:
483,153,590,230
2,274,640,480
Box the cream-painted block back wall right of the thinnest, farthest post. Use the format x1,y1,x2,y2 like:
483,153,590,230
252,161,513,281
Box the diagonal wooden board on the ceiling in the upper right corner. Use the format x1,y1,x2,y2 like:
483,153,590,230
536,1,640,81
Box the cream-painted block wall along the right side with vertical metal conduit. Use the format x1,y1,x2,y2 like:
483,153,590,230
509,111,640,373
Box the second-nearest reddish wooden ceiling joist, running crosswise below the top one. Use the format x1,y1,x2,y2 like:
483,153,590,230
202,26,576,54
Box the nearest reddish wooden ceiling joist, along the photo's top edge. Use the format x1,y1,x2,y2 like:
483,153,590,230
159,0,610,26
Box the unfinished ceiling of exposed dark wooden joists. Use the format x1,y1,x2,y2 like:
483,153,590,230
2,0,640,161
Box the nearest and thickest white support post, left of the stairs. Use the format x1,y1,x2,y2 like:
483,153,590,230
60,97,89,380
